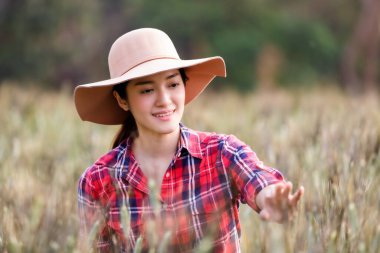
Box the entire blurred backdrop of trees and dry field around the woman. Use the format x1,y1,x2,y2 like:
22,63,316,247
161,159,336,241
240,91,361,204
0,0,380,253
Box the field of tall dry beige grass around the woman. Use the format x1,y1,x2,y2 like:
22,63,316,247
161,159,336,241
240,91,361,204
0,84,380,253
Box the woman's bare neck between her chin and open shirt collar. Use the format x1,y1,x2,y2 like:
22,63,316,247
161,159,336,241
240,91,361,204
133,127,180,158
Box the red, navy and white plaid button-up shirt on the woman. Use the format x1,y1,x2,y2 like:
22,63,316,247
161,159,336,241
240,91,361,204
78,124,284,252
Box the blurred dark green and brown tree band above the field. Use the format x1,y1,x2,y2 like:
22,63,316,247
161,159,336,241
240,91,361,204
0,0,380,92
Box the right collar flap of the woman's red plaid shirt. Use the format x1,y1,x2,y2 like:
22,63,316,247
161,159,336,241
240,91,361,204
178,123,203,159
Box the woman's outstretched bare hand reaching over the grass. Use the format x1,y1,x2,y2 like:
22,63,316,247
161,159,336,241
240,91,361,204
256,182,304,223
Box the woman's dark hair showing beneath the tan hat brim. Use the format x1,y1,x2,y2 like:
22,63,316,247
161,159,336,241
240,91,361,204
112,69,189,148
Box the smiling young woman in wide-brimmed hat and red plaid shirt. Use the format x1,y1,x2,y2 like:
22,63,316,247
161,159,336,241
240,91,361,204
75,28,304,252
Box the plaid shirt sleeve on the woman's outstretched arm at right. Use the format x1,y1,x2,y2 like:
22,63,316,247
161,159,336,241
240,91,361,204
222,135,284,212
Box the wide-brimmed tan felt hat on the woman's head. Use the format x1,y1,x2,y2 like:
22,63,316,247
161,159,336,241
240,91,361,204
74,28,226,125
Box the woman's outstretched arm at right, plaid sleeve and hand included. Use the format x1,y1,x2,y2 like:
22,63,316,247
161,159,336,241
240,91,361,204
222,136,304,222
